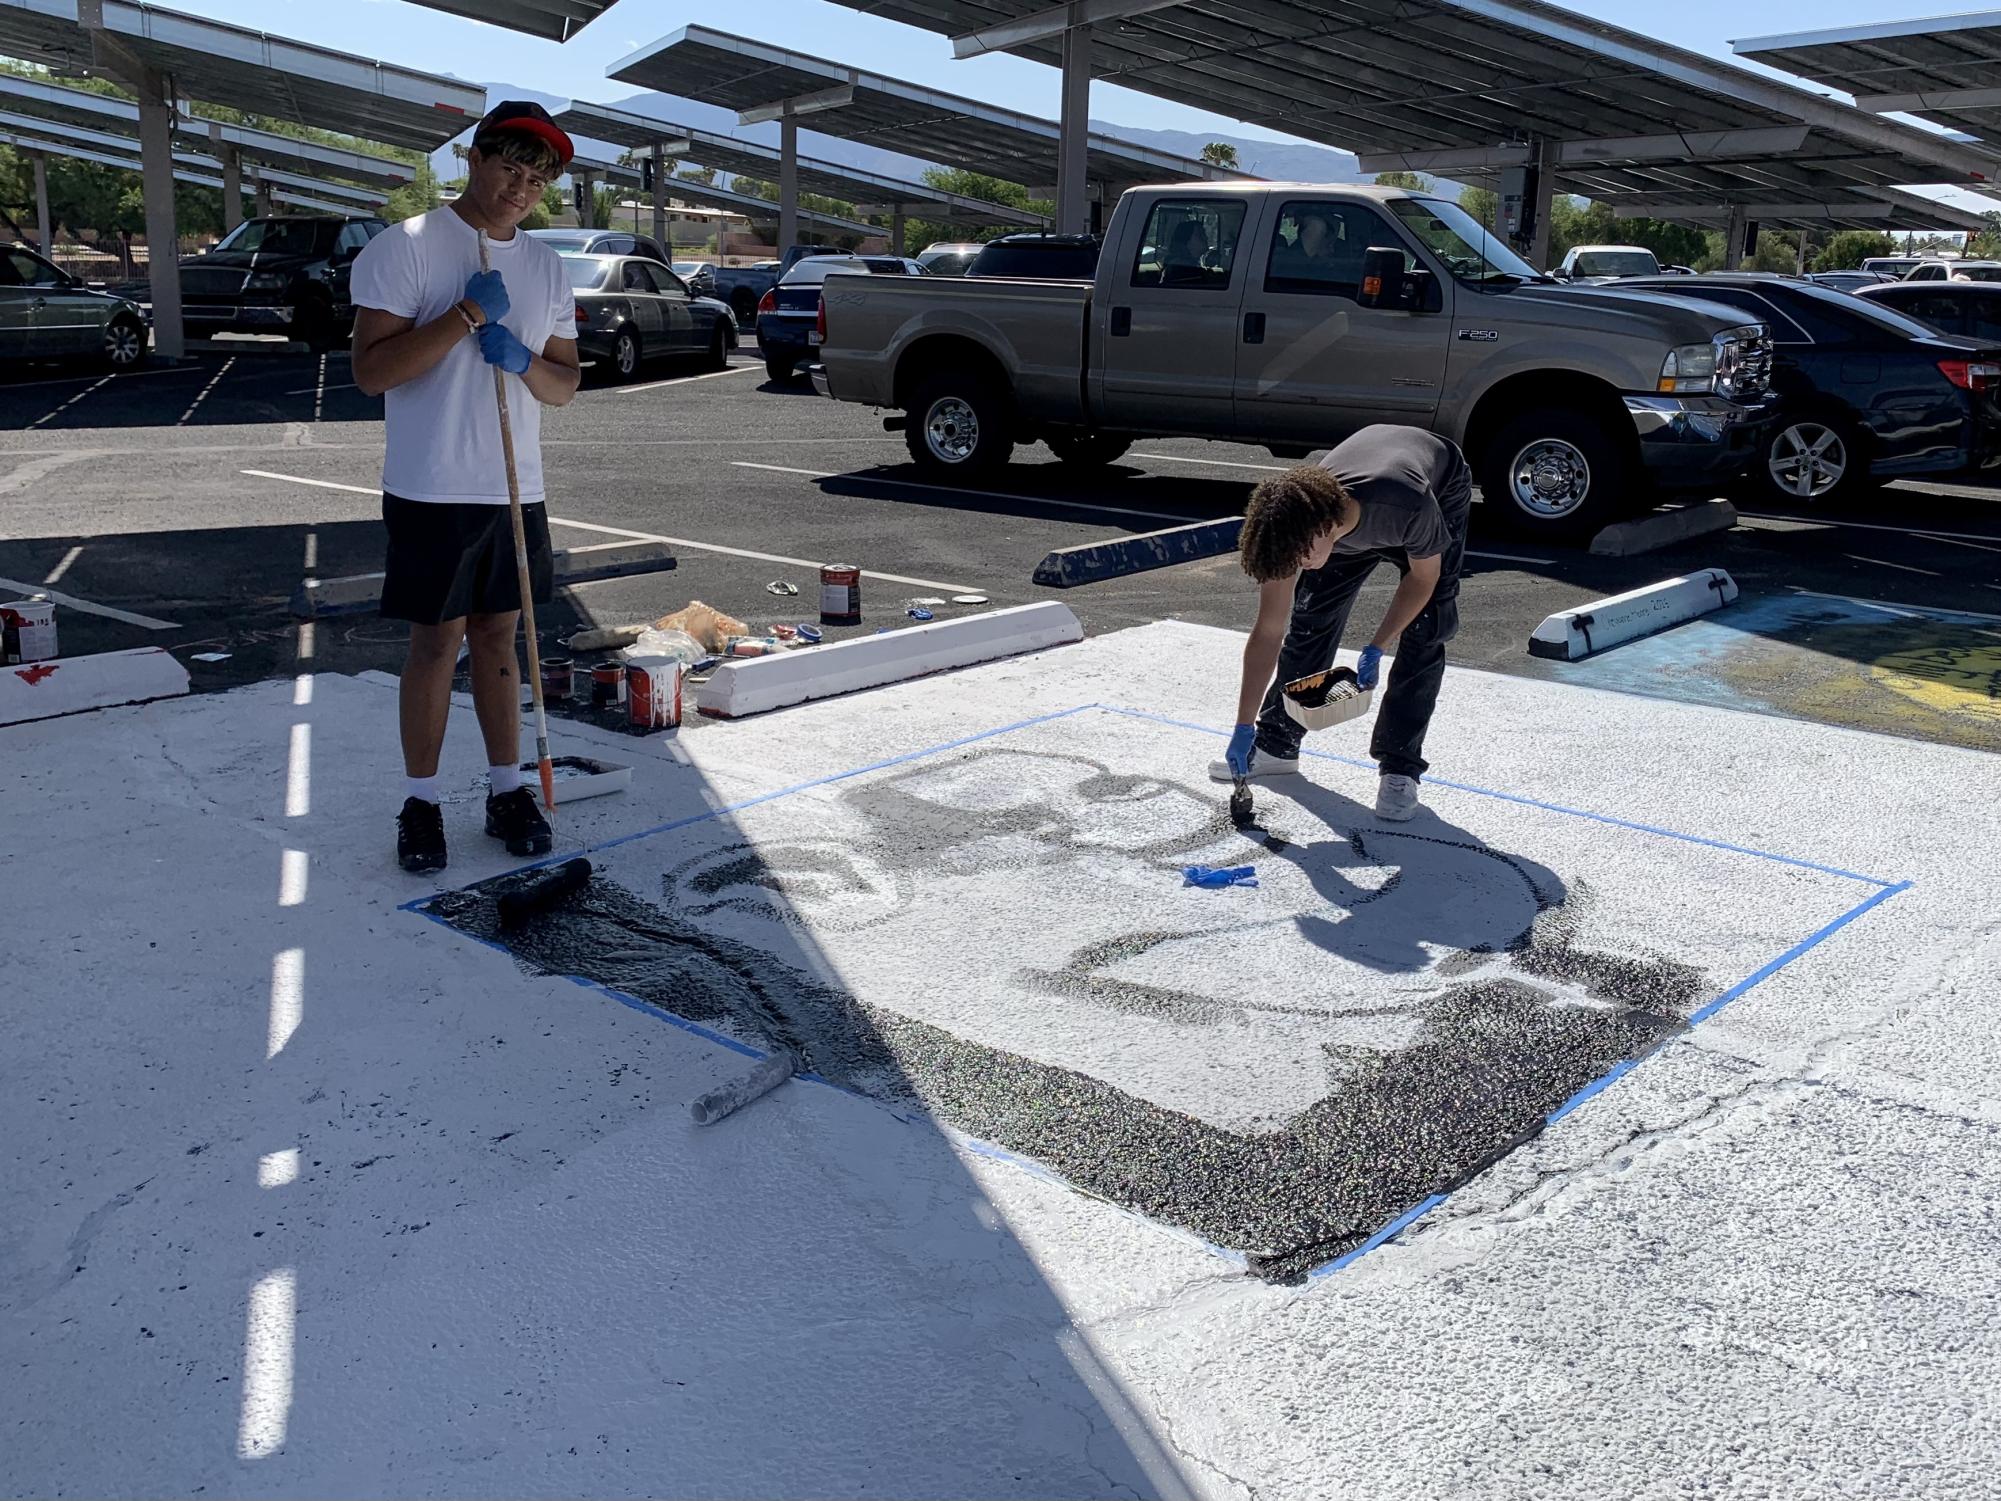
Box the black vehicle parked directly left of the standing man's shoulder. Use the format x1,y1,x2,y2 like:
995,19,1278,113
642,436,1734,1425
180,214,388,350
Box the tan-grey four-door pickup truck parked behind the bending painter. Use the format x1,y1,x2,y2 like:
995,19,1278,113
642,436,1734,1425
814,182,1773,536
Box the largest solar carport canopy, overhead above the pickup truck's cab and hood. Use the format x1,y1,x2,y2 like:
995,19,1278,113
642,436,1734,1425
812,0,2001,256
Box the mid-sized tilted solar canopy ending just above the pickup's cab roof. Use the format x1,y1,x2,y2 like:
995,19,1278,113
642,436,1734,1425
606,26,1245,244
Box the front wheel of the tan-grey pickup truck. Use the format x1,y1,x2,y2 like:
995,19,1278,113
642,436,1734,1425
1479,410,1633,540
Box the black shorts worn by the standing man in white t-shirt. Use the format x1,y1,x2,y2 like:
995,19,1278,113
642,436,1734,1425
382,492,556,624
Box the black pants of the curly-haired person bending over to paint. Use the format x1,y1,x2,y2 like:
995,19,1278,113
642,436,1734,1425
1257,460,1473,777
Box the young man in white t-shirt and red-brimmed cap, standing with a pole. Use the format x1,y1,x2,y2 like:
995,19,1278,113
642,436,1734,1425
352,102,578,873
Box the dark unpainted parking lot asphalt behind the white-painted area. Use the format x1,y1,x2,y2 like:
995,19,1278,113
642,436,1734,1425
0,344,2001,748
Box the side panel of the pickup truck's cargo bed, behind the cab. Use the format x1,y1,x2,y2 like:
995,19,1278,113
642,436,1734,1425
820,276,1091,426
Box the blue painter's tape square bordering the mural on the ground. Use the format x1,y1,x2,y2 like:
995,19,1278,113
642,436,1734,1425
396,702,1913,1281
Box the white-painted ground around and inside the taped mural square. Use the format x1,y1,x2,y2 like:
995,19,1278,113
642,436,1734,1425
0,624,2001,1497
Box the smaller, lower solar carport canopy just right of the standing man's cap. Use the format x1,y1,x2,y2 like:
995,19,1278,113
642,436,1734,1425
556,100,1049,254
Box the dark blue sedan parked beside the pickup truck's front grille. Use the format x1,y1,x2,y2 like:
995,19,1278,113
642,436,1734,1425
1641,272,2001,504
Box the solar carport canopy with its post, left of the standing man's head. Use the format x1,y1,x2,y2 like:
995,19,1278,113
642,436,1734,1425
0,0,486,358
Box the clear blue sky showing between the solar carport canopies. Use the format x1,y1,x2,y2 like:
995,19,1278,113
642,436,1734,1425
168,0,1976,140
